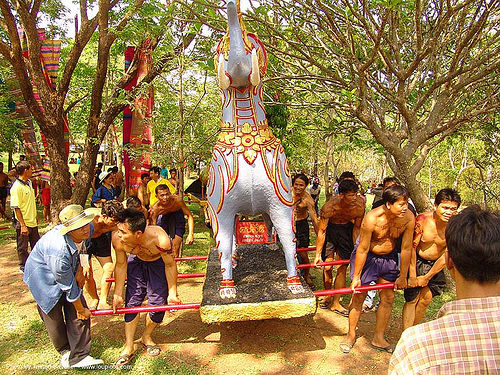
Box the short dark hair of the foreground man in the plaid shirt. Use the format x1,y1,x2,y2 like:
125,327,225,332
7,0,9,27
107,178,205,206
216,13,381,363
445,205,500,283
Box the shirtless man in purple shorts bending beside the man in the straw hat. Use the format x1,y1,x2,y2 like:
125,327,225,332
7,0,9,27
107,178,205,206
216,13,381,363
112,208,181,367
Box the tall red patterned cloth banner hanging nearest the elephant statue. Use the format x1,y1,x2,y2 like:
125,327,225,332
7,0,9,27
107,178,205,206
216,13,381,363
123,40,154,191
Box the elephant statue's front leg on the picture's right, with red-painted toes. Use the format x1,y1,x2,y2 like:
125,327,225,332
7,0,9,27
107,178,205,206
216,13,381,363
269,207,304,294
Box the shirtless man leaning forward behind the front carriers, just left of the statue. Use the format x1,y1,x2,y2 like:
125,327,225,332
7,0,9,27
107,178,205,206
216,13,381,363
149,184,194,257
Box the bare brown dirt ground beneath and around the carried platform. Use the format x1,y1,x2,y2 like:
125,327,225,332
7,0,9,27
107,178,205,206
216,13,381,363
0,244,401,375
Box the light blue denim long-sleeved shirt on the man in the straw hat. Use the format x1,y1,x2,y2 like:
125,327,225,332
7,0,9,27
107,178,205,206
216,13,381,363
23,224,94,314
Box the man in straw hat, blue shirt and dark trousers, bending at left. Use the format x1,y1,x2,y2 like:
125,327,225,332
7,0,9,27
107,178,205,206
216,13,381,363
23,204,103,368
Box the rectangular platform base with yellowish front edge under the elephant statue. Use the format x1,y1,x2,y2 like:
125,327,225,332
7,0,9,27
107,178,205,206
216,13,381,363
200,245,316,323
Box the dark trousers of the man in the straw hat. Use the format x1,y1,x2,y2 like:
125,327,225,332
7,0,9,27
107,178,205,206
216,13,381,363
37,293,90,366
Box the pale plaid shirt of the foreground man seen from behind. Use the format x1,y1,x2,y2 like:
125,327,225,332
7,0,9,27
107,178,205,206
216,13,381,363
389,297,500,375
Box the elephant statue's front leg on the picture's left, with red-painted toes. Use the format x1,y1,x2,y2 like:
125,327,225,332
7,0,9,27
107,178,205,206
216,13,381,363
215,215,236,298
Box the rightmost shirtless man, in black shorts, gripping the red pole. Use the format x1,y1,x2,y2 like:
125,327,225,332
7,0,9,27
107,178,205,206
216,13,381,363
403,189,461,330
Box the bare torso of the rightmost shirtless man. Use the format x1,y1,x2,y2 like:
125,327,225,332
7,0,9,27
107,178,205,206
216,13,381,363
413,211,446,260
